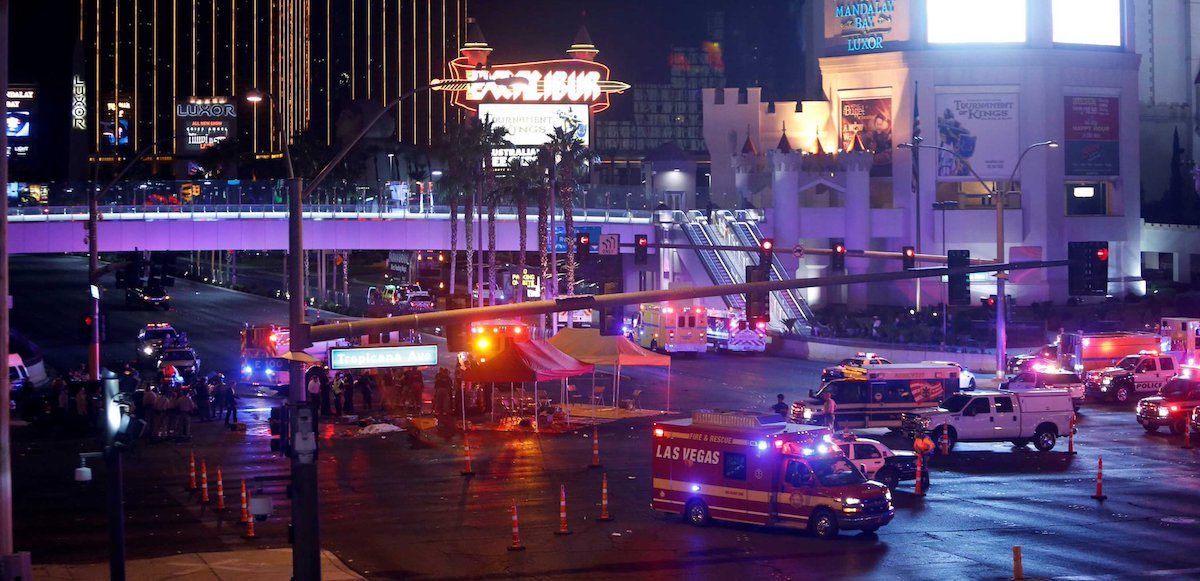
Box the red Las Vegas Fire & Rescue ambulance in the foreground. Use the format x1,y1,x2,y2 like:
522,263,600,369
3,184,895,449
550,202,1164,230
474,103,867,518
650,412,895,539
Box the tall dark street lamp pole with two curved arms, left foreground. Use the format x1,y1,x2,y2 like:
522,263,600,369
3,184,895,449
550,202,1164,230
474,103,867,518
246,73,527,579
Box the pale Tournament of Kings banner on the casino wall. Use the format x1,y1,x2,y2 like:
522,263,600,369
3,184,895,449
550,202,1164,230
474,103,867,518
935,92,1019,180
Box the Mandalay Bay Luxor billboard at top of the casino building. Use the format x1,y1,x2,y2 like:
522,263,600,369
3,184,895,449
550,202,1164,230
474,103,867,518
824,0,912,54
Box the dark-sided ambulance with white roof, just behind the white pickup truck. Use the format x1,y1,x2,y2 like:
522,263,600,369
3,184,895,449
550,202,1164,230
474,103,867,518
791,364,959,429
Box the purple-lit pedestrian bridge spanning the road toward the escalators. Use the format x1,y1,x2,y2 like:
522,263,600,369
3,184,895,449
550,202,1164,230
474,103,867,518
8,204,653,254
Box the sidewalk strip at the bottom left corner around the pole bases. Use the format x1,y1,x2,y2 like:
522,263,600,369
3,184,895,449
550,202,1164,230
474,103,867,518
34,549,364,581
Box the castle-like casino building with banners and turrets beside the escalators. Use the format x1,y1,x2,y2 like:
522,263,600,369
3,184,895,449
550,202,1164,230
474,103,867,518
703,0,1145,305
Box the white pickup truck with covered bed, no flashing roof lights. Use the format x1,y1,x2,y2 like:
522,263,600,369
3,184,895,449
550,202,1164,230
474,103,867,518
900,389,1075,451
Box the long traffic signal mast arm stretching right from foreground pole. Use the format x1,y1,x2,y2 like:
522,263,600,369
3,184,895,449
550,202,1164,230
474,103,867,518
304,259,1068,349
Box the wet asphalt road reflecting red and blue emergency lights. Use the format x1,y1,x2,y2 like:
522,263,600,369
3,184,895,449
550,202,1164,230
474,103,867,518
13,258,1200,580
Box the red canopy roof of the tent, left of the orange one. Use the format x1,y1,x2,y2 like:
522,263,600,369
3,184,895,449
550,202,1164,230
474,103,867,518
466,341,595,383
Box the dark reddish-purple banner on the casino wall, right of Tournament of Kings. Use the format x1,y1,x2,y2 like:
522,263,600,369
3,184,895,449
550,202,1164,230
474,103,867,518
1063,96,1121,176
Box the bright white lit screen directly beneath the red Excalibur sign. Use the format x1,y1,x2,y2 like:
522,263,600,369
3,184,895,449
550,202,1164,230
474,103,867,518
479,103,592,167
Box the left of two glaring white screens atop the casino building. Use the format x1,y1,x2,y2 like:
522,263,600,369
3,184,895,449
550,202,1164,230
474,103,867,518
925,0,1026,44
